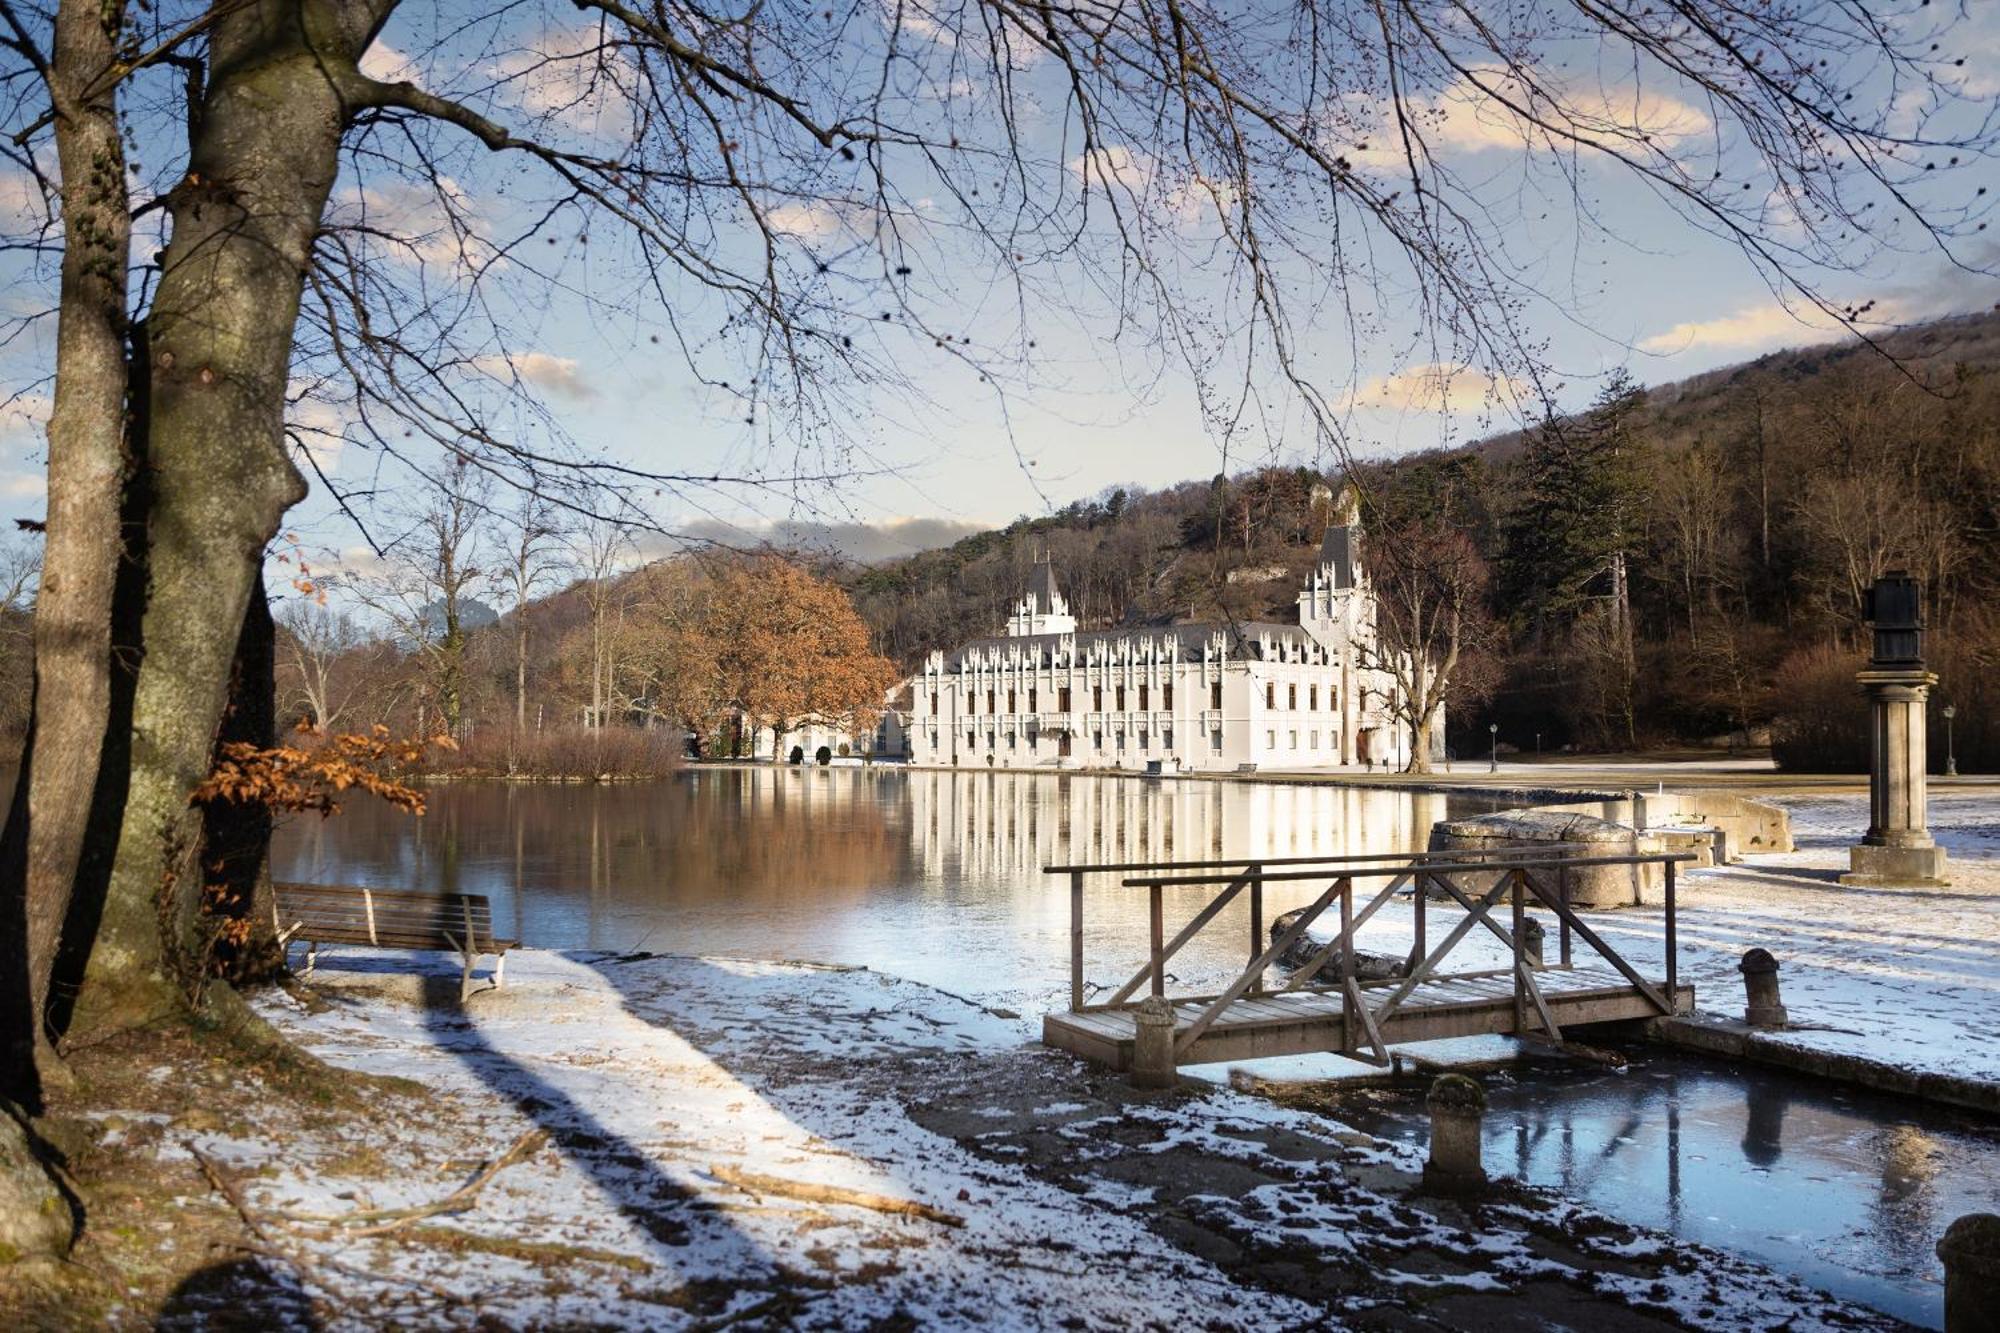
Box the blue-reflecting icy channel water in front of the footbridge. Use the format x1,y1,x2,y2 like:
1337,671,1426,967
1342,1057,2000,1325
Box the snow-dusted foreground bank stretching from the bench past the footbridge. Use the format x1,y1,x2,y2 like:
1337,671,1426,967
145,951,1892,1329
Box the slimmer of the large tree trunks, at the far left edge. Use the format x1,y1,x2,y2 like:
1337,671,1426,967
0,0,132,1105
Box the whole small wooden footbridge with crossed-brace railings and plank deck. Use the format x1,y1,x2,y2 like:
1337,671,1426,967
1042,849,1694,1069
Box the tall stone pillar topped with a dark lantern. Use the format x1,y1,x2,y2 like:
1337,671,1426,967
1840,574,1950,887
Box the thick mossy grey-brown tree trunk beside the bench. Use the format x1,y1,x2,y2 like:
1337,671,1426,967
72,0,386,1033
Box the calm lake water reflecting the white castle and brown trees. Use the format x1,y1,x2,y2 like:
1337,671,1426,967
274,767,1504,1007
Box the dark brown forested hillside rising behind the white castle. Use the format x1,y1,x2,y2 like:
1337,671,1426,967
846,314,2000,763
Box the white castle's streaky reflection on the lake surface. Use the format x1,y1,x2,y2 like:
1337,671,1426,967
908,773,1444,883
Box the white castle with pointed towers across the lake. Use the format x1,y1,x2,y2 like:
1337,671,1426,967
908,496,1444,773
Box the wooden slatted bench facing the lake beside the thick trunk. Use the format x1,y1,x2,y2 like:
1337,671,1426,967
274,883,520,997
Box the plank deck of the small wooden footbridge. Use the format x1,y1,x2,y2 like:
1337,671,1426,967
1042,965,1694,1069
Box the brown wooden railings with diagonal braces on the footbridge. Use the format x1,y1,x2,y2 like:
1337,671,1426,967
1046,847,1696,1063
